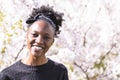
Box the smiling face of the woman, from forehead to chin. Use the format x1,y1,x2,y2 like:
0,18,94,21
27,20,55,57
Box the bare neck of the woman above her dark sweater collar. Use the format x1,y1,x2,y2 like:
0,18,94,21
22,55,48,66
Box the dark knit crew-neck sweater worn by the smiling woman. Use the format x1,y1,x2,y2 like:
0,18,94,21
0,59,68,80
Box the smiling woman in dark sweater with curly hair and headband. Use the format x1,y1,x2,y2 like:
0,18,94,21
0,6,68,80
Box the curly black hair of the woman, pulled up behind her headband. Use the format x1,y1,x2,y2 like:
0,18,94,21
26,5,63,37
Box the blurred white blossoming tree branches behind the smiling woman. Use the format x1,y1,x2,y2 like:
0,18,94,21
0,0,120,80
